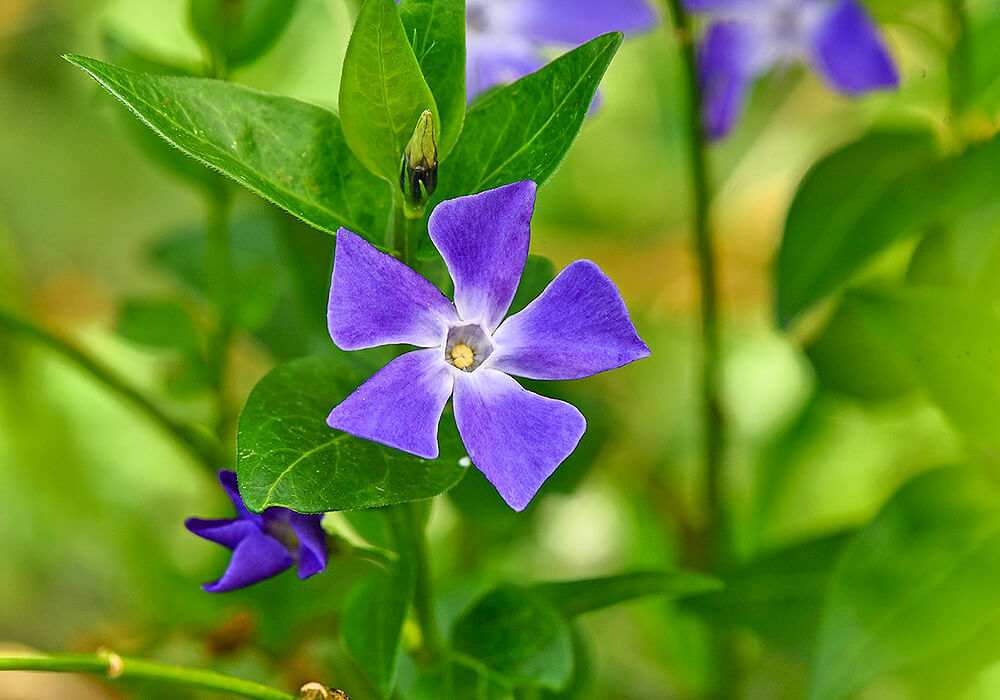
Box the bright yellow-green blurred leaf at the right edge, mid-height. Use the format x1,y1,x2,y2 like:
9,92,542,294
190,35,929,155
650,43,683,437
843,287,1000,448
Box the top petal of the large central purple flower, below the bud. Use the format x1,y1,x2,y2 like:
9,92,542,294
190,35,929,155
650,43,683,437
428,180,535,331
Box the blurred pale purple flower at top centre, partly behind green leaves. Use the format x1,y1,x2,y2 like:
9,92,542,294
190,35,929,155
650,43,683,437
465,0,656,100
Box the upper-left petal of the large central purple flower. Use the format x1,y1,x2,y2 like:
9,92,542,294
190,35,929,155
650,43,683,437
327,229,458,350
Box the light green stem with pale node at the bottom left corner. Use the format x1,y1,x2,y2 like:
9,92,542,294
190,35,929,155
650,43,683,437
0,652,295,700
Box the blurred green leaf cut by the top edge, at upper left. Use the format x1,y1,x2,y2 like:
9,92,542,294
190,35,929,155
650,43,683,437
190,0,298,68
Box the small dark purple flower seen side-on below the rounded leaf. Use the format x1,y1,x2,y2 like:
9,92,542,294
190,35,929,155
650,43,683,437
184,471,327,593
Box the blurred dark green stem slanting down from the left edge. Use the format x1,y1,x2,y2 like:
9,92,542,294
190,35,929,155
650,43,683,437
0,309,221,471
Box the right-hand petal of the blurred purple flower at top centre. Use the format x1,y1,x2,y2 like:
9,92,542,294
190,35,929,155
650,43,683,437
511,0,656,45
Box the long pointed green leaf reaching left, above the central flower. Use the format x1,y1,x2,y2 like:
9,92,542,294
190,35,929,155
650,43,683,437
65,55,392,241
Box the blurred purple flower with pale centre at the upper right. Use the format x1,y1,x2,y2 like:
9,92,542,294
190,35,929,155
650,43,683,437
685,0,899,139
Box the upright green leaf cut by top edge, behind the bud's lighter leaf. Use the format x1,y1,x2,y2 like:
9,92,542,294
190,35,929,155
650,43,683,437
399,0,466,161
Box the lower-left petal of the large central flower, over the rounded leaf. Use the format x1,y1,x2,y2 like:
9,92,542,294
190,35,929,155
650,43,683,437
326,348,454,459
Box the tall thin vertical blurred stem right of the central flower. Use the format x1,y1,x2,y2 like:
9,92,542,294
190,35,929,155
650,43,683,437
667,0,726,567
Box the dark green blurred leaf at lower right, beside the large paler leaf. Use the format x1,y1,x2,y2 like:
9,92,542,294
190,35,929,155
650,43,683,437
681,533,852,659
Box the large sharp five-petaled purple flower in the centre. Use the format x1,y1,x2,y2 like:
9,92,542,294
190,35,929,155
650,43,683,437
328,181,649,510
